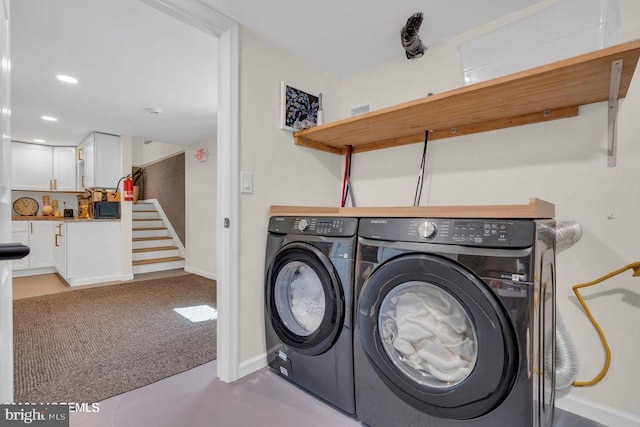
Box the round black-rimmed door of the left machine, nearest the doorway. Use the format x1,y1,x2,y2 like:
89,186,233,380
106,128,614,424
265,242,345,355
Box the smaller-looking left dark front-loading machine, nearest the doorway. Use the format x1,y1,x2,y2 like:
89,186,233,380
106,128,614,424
265,217,358,415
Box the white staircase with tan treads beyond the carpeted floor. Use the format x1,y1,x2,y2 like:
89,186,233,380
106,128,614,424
132,201,185,274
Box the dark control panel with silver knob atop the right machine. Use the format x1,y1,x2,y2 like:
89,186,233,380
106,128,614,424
359,218,535,247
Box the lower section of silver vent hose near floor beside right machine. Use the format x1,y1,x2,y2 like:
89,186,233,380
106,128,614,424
545,310,580,390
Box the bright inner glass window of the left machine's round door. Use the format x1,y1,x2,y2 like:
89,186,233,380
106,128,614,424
289,265,325,332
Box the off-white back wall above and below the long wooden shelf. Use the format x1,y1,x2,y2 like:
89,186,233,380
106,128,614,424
341,0,640,425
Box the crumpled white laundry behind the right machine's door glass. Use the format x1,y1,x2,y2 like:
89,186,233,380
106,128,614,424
379,282,477,387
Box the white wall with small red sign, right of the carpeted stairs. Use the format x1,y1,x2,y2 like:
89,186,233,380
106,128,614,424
184,136,217,279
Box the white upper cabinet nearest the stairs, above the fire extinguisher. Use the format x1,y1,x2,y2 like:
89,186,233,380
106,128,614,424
78,133,121,189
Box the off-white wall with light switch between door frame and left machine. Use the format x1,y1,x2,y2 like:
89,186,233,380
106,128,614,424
238,28,341,361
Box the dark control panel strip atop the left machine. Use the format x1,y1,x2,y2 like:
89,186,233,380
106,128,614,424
269,216,358,237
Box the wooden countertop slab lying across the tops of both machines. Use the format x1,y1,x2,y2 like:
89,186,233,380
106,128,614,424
269,198,555,219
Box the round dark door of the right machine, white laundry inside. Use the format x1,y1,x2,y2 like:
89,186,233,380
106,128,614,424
357,253,518,419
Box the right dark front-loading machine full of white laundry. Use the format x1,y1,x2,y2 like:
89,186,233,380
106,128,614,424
354,218,555,427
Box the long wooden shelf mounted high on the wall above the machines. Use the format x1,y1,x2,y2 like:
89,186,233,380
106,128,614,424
294,41,640,154
